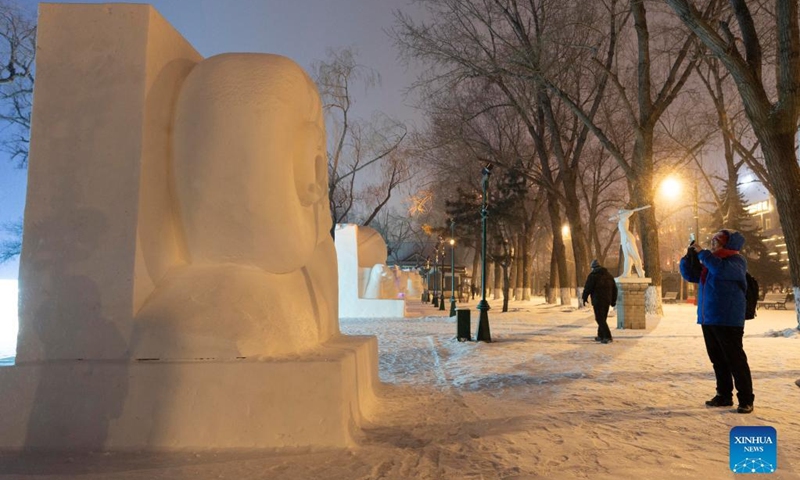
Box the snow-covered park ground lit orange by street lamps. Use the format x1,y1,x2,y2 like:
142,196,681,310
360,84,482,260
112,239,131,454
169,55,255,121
0,298,800,480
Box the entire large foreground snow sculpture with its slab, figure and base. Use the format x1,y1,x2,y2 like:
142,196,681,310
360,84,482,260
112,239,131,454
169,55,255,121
0,4,377,450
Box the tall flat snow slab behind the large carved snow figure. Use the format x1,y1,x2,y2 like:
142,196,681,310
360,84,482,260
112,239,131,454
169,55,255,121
17,4,202,363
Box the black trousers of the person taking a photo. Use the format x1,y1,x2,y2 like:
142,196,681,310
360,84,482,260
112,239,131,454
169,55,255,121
702,325,754,405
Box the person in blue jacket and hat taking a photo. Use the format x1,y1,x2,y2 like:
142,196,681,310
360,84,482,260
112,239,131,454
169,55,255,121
681,229,755,413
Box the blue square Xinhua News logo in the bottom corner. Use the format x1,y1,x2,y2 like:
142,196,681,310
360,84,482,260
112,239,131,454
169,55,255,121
730,427,778,473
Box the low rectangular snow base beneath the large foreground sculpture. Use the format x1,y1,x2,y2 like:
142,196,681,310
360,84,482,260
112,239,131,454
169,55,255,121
0,336,378,450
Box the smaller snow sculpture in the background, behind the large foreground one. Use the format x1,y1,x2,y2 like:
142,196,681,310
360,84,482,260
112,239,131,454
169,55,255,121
336,224,405,318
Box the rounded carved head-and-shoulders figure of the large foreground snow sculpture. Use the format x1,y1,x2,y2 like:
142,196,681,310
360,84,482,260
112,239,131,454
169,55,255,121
133,54,338,359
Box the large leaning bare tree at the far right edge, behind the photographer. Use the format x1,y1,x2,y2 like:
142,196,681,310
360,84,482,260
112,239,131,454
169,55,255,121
664,0,800,328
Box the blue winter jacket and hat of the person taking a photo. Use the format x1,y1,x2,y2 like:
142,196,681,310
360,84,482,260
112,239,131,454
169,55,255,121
681,231,747,327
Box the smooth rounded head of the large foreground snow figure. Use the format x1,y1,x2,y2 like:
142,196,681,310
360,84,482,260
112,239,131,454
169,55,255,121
173,54,330,273
